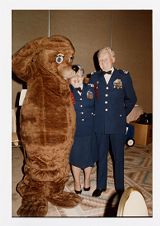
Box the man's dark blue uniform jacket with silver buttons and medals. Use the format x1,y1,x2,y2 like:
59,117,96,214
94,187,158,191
90,69,137,134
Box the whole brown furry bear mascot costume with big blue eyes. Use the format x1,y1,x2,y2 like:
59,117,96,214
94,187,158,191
12,35,81,216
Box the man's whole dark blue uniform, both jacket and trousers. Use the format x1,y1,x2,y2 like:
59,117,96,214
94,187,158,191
90,69,137,191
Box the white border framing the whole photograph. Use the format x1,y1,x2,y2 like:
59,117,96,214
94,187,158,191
0,0,160,226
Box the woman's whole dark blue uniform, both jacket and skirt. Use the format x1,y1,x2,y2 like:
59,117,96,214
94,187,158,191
69,84,97,169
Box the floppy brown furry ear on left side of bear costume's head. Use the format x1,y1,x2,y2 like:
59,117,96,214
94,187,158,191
12,38,46,82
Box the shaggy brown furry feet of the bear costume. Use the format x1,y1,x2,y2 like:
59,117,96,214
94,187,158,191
17,176,81,217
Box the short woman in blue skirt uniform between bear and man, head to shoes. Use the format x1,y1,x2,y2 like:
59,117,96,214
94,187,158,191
70,65,96,194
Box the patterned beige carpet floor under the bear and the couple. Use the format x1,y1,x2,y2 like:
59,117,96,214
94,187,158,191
12,144,152,217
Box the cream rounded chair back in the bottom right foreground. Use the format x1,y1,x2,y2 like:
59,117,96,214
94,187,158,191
117,187,148,217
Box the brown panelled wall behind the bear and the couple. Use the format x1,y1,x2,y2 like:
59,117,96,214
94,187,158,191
12,10,152,112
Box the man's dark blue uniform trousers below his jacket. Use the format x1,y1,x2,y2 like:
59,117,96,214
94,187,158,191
96,134,125,192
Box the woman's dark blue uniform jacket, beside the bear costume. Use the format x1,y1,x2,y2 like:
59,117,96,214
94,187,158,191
70,84,95,136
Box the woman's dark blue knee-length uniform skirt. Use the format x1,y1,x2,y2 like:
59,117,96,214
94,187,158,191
69,135,97,169
